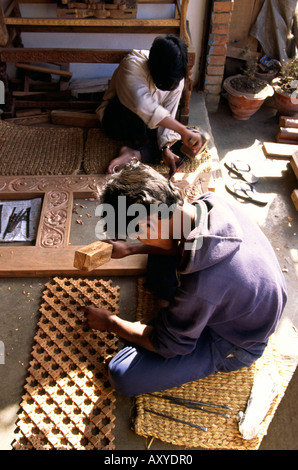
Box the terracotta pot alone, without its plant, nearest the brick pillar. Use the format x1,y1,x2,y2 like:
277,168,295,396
223,75,274,121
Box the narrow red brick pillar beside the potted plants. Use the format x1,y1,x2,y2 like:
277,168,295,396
204,0,234,111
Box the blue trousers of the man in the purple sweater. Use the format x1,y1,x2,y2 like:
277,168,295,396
109,256,266,396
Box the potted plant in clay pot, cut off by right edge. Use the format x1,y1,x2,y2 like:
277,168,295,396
272,58,298,116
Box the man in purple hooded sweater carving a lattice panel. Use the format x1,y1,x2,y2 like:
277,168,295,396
86,162,287,396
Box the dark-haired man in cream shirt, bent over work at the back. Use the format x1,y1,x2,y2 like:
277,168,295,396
96,35,202,173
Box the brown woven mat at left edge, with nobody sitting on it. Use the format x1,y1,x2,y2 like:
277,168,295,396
0,120,84,176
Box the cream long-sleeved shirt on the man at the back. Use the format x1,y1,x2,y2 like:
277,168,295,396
96,50,184,149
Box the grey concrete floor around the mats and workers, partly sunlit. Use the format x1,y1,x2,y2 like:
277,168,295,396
0,92,298,450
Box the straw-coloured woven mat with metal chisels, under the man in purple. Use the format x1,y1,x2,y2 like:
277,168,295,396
134,279,296,450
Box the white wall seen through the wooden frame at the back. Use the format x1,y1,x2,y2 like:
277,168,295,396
1,0,207,83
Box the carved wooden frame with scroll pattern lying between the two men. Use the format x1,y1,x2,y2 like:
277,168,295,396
0,175,147,277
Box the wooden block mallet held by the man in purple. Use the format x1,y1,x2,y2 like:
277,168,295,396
73,241,113,271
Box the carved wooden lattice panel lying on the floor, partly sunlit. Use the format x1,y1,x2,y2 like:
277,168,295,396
12,278,119,450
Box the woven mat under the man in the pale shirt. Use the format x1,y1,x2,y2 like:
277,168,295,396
83,129,211,176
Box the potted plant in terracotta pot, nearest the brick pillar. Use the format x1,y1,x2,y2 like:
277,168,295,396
223,60,274,121
